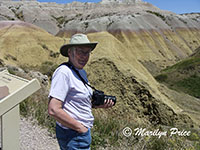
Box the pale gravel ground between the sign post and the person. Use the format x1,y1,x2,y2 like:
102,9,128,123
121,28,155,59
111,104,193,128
0,118,59,150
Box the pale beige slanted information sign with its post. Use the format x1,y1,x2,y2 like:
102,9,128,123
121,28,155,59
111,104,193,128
0,71,40,150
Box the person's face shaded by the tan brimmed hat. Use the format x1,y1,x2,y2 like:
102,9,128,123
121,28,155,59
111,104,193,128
68,46,91,69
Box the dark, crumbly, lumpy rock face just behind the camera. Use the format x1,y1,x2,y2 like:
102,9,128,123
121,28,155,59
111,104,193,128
88,59,192,127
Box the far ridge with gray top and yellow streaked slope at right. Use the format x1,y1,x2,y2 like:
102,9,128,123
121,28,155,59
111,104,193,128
0,0,200,74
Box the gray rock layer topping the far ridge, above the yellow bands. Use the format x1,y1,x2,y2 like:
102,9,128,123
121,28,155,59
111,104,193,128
0,0,200,35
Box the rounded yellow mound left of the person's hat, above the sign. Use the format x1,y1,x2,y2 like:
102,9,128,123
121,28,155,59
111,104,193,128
0,21,64,66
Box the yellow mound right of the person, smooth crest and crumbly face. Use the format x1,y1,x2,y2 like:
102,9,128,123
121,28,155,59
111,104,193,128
84,33,198,127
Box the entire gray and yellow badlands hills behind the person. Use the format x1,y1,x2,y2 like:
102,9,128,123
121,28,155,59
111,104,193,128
0,0,200,141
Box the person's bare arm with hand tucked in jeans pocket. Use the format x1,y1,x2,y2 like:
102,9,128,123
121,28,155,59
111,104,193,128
48,98,88,133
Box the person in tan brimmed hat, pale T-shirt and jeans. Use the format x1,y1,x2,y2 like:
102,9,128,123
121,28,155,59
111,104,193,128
48,34,114,150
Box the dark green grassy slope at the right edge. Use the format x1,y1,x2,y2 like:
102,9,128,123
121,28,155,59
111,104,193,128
155,47,200,98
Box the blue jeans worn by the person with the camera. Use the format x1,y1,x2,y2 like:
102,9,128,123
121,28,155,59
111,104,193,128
56,124,91,150
